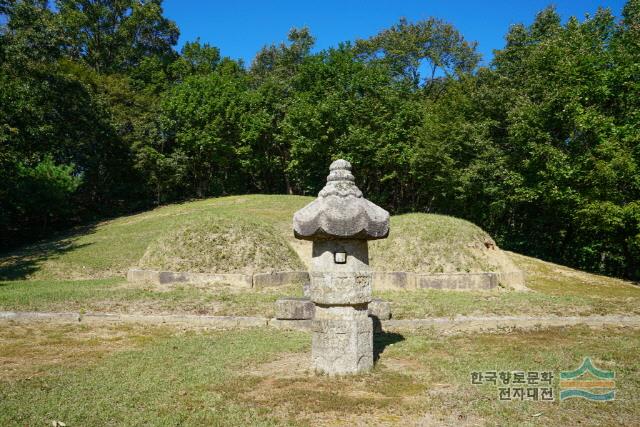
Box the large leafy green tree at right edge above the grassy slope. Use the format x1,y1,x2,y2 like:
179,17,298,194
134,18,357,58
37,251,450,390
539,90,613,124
484,6,640,275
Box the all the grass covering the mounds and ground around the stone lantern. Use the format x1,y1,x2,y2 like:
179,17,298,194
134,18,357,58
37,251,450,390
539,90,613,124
0,196,640,426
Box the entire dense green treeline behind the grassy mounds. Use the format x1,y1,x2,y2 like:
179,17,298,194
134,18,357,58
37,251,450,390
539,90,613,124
0,0,640,279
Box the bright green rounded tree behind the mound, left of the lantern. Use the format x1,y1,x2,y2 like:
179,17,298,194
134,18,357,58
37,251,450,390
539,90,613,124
161,60,247,197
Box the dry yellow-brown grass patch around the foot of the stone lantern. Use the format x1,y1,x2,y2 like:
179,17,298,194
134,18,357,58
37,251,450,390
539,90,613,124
228,360,428,425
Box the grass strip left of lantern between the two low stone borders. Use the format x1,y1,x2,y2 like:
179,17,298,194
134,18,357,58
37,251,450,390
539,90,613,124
0,278,302,317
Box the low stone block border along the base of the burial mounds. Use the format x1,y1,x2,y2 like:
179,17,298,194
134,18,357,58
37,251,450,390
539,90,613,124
127,269,524,290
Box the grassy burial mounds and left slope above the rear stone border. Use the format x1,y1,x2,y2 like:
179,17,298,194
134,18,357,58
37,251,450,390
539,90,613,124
0,195,512,280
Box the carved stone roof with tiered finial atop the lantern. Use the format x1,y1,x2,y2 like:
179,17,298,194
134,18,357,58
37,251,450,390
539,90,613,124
293,160,389,240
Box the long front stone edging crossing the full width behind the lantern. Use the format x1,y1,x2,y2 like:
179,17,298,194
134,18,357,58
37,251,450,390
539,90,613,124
0,311,640,332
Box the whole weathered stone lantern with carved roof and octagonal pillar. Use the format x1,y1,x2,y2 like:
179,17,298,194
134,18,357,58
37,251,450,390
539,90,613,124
293,160,389,375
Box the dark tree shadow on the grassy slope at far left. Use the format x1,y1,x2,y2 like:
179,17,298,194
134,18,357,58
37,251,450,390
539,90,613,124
0,225,95,280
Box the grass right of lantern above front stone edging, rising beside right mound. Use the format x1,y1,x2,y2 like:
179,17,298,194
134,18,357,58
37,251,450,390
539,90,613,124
375,253,640,319
